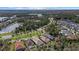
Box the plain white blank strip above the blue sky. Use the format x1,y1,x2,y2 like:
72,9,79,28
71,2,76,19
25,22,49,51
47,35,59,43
0,0,79,7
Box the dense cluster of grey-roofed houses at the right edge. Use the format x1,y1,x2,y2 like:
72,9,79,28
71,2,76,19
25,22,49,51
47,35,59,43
57,19,79,39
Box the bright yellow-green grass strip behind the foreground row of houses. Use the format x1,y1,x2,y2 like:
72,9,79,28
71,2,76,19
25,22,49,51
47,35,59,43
0,31,43,40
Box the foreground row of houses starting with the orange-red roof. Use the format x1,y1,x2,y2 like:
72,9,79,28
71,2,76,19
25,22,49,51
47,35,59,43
13,34,54,51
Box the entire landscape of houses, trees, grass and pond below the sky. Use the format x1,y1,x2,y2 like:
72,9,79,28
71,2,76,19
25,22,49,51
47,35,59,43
0,10,79,51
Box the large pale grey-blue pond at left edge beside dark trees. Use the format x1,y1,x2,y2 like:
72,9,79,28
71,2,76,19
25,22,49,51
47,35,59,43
0,23,20,34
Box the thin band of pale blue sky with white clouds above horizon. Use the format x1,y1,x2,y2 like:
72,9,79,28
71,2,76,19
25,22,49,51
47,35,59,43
0,7,79,10
